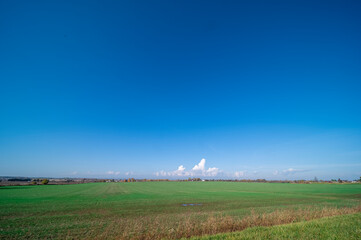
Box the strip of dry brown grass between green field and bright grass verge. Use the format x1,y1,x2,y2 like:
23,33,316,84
59,206,361,240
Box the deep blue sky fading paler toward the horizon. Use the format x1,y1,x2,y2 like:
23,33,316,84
0,1,361,179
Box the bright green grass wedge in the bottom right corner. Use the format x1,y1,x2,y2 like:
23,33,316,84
191,213,361,240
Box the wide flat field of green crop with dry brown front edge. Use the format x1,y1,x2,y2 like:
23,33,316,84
0,182,361,239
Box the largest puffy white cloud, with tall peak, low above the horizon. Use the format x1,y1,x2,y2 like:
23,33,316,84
155,158,220,177
